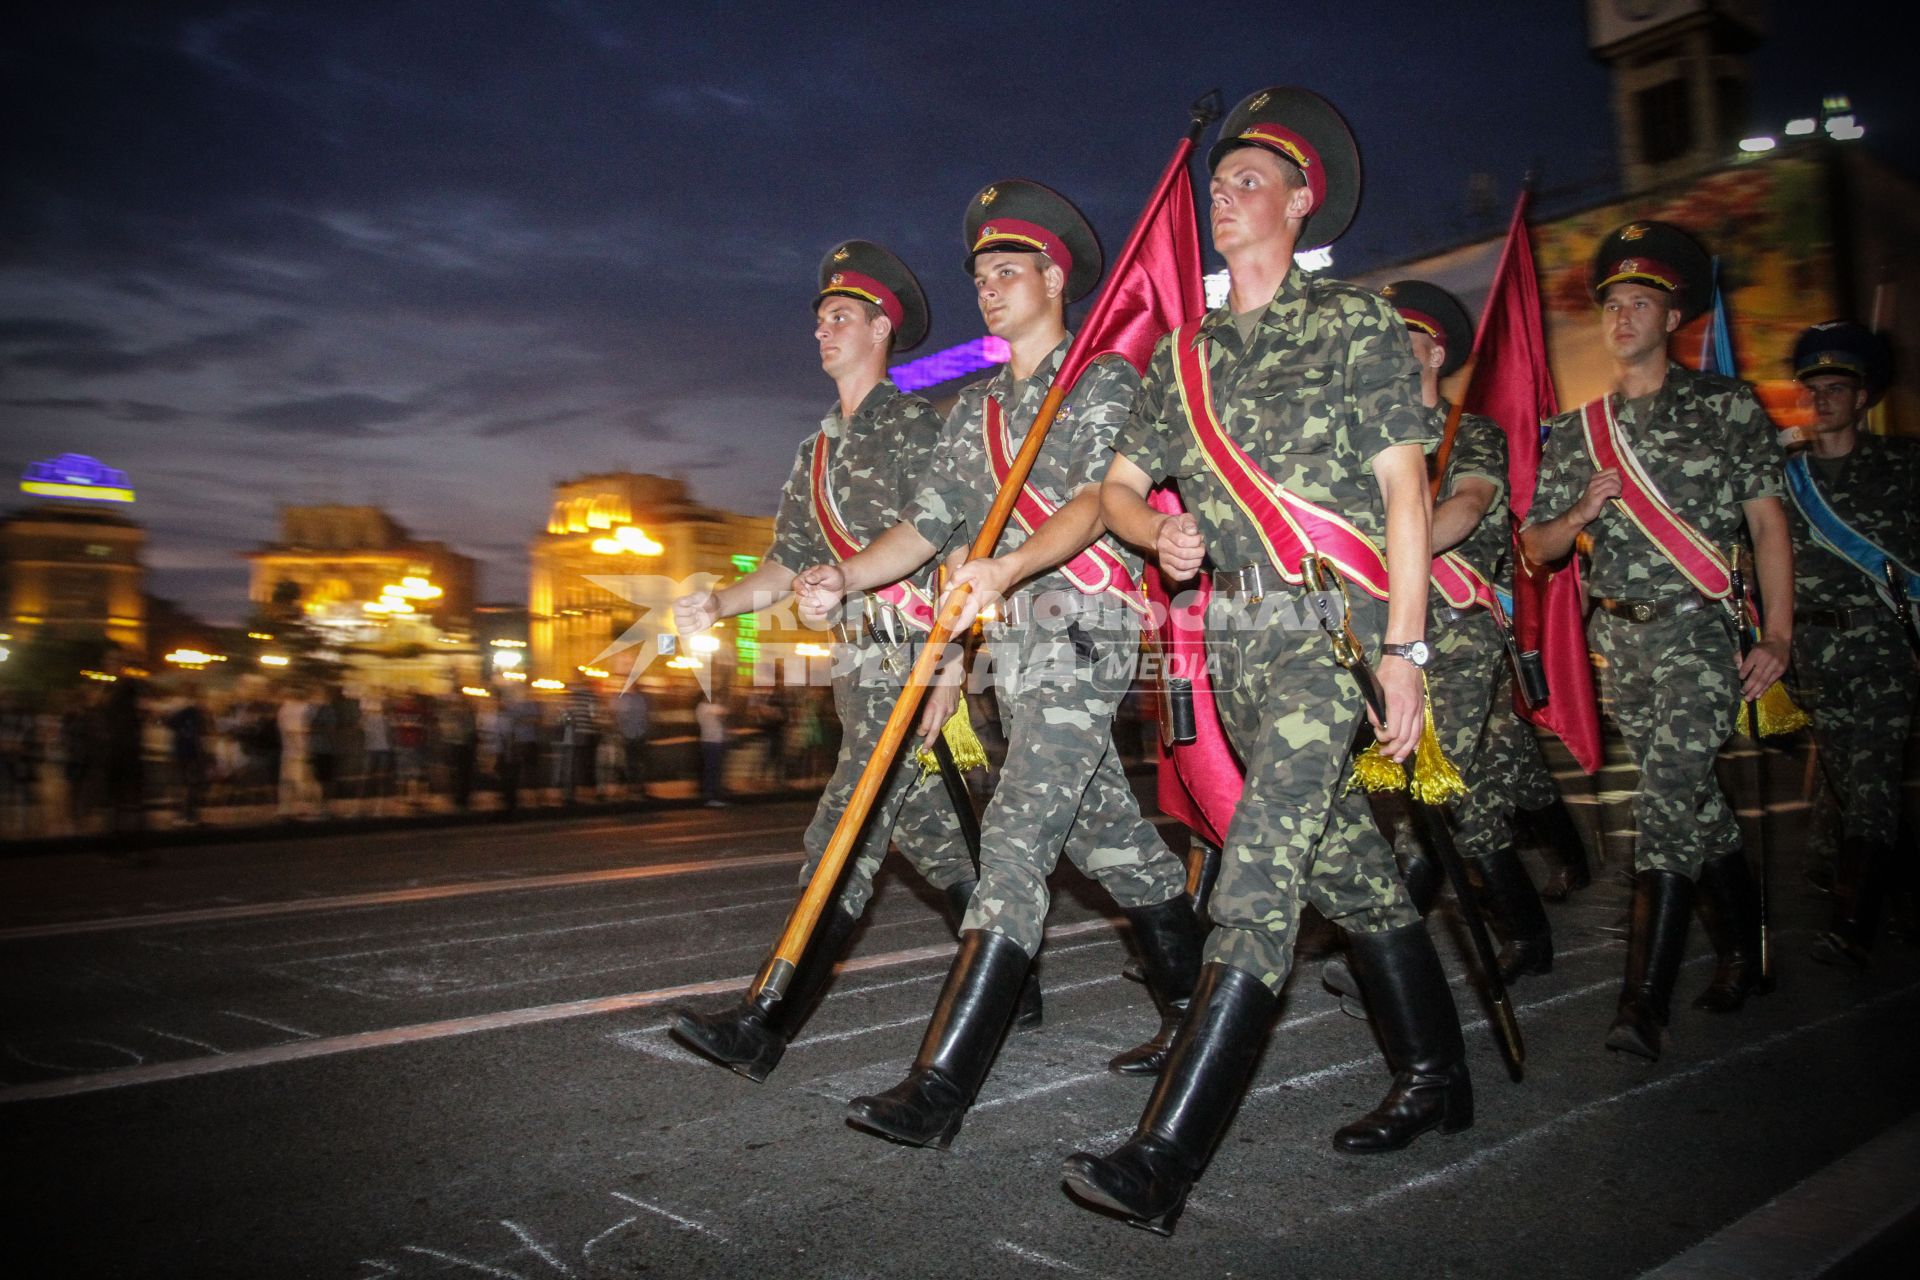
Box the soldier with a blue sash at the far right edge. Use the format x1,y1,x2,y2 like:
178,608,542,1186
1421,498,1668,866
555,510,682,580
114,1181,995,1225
1786,320,1920,965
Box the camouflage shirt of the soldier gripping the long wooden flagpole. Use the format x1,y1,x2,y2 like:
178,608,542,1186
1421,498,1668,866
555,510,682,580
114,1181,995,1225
900,334,1140,593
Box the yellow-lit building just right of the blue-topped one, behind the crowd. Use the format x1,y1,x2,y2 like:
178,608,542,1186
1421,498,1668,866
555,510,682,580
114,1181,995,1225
246,507,474,628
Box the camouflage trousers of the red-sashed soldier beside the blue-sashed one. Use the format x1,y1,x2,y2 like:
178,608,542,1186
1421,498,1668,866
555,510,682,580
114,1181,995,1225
1588,604,1740,879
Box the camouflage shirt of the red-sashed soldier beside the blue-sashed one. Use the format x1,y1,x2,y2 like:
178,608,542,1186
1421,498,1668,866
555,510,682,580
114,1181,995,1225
1528,365,1786,597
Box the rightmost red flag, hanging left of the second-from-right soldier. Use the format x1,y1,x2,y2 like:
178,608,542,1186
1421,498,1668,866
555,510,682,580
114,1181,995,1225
1461,192,1601,773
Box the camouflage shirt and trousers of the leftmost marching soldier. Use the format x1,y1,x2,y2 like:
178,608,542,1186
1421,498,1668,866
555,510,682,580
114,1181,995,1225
766,382,973,917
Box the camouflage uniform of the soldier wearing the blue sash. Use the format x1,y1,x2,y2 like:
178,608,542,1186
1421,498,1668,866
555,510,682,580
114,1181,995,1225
1788,432,1920,844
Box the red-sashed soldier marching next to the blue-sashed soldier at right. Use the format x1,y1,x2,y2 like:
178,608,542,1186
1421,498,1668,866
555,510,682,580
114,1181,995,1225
1521,223,1793,1057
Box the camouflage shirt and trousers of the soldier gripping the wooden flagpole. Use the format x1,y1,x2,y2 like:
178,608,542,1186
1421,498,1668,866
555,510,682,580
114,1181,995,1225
900,338,1187,956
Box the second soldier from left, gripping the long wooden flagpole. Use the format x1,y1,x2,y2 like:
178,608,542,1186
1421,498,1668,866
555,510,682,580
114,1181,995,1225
797,180,1198,1146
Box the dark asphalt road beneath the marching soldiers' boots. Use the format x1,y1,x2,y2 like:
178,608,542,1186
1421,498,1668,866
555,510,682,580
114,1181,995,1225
0,758,1920,1280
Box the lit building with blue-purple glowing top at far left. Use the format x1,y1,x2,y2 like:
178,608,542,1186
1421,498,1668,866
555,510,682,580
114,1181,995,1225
0,453,146,654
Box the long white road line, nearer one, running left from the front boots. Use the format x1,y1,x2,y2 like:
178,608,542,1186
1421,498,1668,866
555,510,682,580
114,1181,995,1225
0,917,1116,1105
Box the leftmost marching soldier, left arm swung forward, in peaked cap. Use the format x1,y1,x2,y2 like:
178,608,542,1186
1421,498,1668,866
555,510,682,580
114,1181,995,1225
674,240,1041,1080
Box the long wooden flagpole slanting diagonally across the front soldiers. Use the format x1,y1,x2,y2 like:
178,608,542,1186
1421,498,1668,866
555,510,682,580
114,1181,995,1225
747,105,1217,1009
